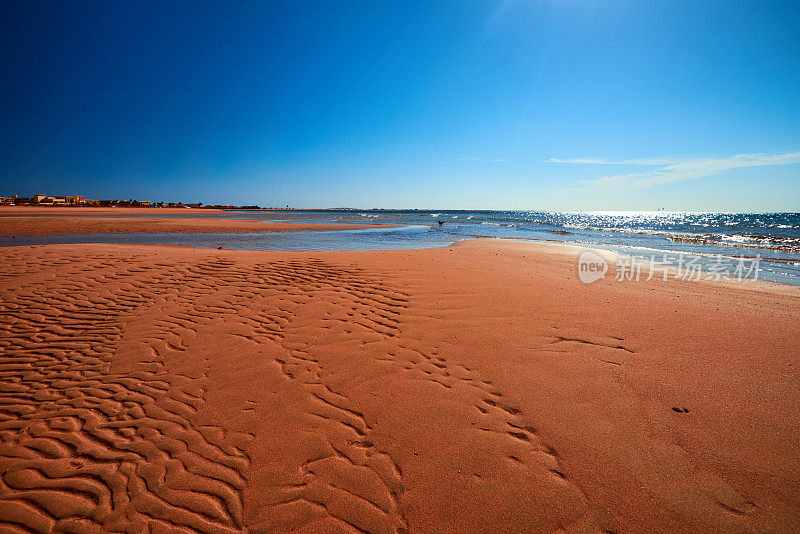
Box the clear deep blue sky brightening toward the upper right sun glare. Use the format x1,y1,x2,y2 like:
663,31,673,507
0,0,800,211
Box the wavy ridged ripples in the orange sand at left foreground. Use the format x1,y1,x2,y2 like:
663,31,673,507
0,249,406,533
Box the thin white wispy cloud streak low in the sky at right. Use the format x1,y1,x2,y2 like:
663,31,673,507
547,152,800,189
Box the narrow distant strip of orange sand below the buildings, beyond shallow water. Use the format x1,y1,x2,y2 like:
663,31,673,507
0,210,397,236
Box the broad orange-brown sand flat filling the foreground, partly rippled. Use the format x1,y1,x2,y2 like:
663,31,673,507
0,240,800,533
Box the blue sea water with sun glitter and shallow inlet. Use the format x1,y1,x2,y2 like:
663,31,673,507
0,210,800,285
